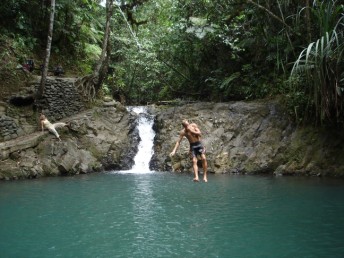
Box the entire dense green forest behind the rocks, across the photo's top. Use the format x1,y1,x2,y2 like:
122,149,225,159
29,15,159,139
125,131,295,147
0,0,344,125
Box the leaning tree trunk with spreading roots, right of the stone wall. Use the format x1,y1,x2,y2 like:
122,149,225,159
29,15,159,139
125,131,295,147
92,0,113,93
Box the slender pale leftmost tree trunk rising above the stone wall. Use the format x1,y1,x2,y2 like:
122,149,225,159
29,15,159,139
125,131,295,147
37,0,55,99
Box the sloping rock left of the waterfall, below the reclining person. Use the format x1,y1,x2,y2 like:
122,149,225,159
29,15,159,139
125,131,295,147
0,103,140,179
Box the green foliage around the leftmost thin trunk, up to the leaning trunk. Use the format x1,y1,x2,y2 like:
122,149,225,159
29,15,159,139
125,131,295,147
0,0,105,74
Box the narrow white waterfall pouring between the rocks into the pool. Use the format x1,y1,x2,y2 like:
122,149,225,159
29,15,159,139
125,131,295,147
127,106,155,174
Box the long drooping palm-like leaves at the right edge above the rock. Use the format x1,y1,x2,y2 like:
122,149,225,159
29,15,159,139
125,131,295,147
291,17,344,122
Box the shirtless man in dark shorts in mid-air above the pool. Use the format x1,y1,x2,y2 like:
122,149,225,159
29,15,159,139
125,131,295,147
170,119,208,182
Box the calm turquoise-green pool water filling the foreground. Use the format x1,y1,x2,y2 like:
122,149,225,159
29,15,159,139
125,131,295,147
0,172,344,258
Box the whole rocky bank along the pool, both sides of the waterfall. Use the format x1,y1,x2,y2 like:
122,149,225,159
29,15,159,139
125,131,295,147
0,100,344,180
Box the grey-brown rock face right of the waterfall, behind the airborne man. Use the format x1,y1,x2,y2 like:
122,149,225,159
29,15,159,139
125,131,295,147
150,101,344,176
